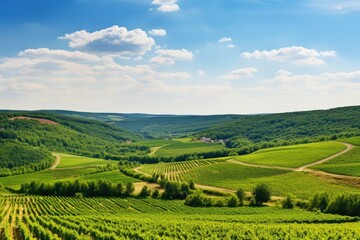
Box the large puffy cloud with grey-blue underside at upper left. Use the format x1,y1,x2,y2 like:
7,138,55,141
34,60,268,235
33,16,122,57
59,25,155,55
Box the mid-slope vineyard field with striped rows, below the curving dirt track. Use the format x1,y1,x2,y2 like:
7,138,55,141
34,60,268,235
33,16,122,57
140,160,360,199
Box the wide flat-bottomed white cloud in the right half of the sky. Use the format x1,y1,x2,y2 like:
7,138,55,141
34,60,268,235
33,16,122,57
241,46,336,65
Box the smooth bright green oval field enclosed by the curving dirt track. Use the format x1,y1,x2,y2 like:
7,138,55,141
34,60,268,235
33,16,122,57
234,142,346,167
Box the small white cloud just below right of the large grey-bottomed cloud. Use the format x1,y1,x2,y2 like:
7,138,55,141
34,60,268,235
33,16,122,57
150,49,194,65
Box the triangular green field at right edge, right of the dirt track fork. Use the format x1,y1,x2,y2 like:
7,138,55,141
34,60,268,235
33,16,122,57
313,147,360,177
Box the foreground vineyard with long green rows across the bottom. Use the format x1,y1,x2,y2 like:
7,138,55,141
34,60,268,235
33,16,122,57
0,196,360,240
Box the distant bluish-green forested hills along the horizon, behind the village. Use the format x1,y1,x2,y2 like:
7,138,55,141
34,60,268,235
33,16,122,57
43,106,360,142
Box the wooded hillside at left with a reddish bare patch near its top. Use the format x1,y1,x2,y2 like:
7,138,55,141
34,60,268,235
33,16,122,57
0,112,149,158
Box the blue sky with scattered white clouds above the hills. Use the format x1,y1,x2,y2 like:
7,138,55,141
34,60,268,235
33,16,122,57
0,0,360,114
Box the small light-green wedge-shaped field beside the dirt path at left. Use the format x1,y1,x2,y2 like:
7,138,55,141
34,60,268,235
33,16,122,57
57,153,117,169
